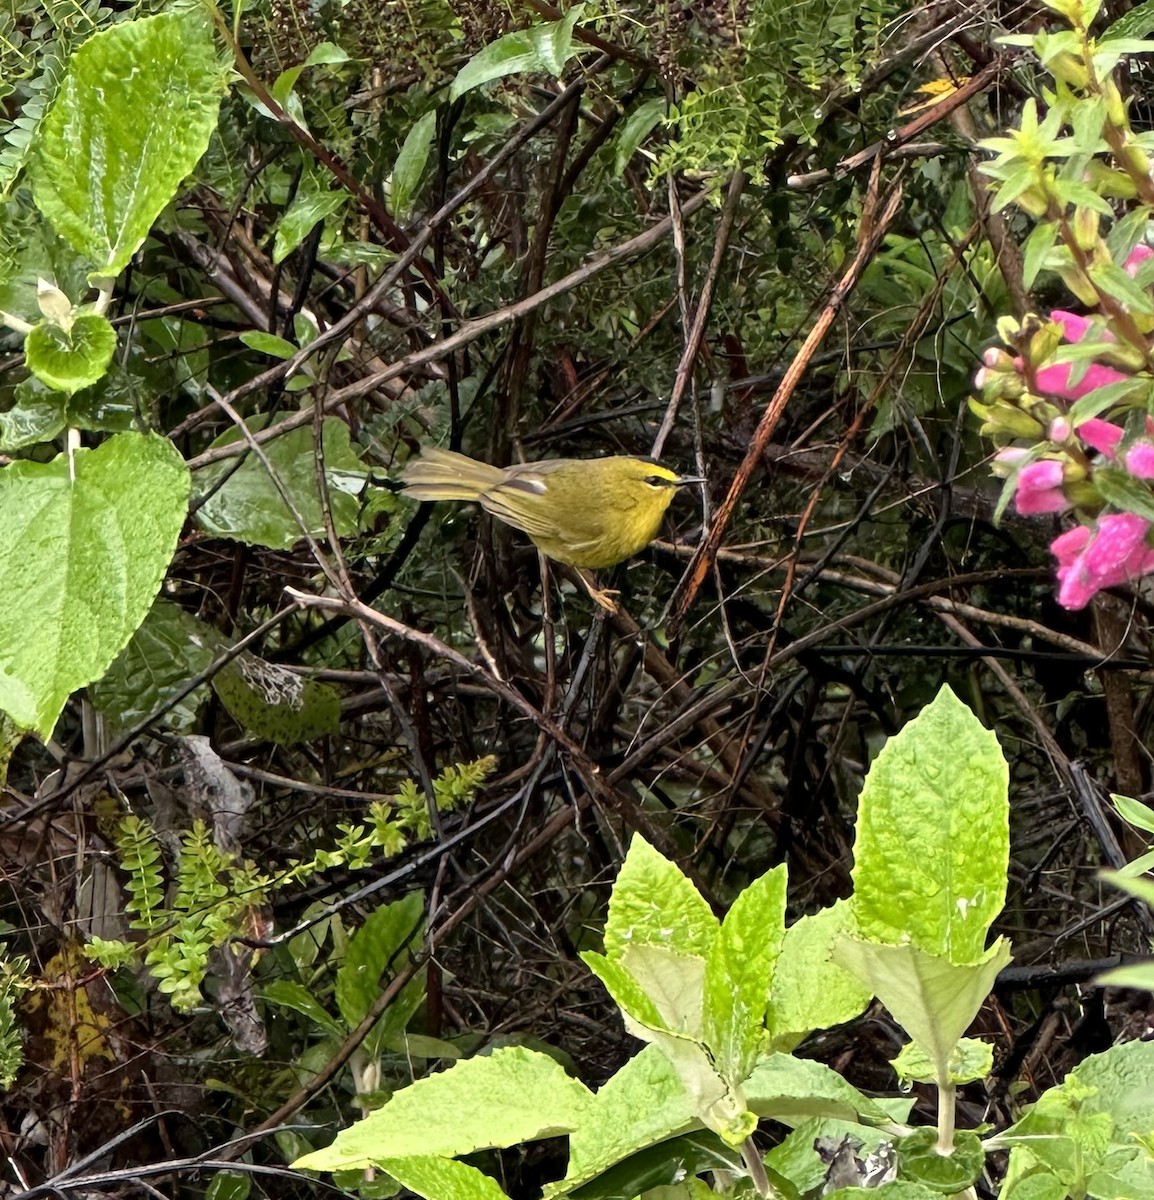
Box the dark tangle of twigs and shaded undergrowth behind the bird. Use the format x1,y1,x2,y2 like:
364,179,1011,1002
0,0,1152,1194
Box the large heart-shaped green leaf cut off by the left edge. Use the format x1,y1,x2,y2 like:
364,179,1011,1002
0,433,188,738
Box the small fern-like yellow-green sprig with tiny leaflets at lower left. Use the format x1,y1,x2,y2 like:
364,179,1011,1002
92,756,497,1012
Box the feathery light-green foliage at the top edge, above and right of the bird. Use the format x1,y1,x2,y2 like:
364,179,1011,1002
656,0,902,174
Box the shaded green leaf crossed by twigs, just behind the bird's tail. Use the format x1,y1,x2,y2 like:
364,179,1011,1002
196,416,365,550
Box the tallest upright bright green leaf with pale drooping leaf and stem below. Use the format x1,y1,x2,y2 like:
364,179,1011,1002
834,688,1010,1132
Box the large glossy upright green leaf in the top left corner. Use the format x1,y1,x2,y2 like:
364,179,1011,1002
31,7,227,276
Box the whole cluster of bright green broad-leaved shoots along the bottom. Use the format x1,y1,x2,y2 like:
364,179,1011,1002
296,689,1046,1200
